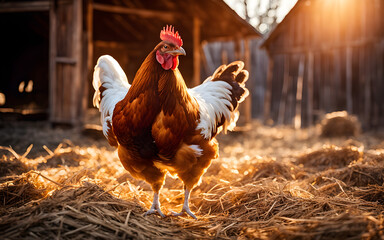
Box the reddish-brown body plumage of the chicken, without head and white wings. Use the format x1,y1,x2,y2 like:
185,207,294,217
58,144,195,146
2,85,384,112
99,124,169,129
112,45,218,191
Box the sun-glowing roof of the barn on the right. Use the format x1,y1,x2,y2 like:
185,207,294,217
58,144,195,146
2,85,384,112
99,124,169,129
261,0,384,51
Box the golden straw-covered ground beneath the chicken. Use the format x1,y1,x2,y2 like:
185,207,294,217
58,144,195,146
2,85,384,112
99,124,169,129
0,116,384,239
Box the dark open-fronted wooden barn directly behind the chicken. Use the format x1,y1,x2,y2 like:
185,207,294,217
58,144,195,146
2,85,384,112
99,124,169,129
0,0,260,125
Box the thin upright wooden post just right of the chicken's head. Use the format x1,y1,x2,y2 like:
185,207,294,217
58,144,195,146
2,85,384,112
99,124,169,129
193,16,201,86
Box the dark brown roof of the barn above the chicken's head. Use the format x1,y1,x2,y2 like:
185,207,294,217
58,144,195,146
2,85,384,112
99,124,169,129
93,0,261,42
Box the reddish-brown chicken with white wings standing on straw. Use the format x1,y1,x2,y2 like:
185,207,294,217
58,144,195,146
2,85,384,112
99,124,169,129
93,26,248,219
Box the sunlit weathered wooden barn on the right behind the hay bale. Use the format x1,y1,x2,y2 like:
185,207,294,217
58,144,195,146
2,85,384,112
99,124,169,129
262,0,384,129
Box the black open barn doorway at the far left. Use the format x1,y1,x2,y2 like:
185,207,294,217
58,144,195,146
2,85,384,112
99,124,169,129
0,11,49,120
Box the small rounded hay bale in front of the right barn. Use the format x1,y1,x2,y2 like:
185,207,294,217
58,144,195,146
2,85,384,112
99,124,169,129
320,111,361,137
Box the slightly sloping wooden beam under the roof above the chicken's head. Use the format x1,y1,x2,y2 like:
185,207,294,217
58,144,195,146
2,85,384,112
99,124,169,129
93,3,177,22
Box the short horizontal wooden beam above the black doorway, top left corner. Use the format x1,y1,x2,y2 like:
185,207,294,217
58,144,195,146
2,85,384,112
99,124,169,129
0,1,50,13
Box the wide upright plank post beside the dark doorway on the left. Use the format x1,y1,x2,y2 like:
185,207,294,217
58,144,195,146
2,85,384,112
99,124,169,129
49,0,86,126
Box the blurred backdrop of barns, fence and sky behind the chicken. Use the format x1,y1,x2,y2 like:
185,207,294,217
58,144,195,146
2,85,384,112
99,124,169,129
0,0,384,130
